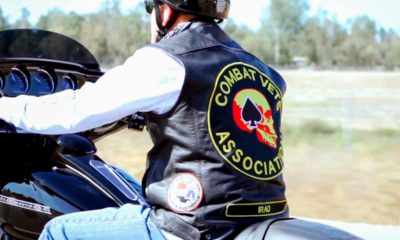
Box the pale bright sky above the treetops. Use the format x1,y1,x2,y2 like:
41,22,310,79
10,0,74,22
0,0,400,33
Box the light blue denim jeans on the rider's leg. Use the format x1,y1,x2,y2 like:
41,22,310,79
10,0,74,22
39,169,165,240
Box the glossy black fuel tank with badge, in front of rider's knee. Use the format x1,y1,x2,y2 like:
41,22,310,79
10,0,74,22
0,169,117,237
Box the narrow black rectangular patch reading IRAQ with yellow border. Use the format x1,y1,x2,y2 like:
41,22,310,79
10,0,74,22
225,200,287,217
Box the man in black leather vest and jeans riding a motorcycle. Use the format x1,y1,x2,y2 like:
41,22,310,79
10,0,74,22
0,0,288,239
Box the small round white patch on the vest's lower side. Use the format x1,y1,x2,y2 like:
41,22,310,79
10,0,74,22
167,173,203,212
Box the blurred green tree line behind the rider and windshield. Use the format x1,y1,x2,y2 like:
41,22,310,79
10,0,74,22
0,0,400,70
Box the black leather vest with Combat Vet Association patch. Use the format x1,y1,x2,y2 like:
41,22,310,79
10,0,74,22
143,22,288,239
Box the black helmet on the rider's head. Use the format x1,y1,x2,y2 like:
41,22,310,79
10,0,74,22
159,0,231,20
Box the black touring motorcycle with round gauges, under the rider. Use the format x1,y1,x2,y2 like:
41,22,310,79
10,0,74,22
0,29,358,240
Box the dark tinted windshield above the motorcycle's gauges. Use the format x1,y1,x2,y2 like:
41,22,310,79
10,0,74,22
0,29,100,70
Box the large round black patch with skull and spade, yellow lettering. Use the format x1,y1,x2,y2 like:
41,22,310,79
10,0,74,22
207,62,283,180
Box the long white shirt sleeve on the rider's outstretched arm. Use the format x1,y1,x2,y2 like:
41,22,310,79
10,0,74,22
0,46,185,134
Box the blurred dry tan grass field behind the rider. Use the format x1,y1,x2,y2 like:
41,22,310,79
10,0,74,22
96,71,400,225
